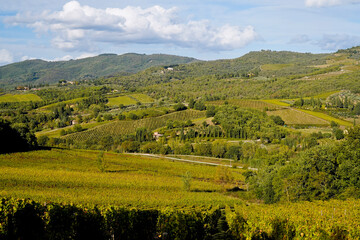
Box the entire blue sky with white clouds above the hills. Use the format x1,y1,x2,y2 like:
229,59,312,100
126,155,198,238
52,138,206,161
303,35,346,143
0,0,360,66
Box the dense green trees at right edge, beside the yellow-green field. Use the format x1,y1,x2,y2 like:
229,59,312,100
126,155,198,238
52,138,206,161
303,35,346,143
247,126,360,203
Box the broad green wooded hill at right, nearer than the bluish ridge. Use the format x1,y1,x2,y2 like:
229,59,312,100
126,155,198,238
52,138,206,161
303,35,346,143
100,48,360,101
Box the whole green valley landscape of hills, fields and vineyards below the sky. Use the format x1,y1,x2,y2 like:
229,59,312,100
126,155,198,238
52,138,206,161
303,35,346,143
0,47,360,239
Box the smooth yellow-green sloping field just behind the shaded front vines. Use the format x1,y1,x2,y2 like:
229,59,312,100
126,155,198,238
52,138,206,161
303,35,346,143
0,149,243,207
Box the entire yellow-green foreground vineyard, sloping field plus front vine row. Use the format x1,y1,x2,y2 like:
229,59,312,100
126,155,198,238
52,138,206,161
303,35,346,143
0,149,360,239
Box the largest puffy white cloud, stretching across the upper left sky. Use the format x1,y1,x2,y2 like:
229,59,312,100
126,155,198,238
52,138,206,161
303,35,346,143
6,1,257,52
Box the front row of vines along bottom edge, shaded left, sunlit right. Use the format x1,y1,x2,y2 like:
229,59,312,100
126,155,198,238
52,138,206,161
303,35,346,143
0,199,360,240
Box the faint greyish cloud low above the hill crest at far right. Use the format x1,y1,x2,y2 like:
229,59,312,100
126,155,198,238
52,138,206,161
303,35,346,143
316,34,360,51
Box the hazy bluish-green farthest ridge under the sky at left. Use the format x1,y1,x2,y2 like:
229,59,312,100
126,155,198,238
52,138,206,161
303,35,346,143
0,53,198,88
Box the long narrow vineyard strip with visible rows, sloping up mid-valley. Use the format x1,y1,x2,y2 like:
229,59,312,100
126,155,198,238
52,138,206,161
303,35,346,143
64,110,205,142
